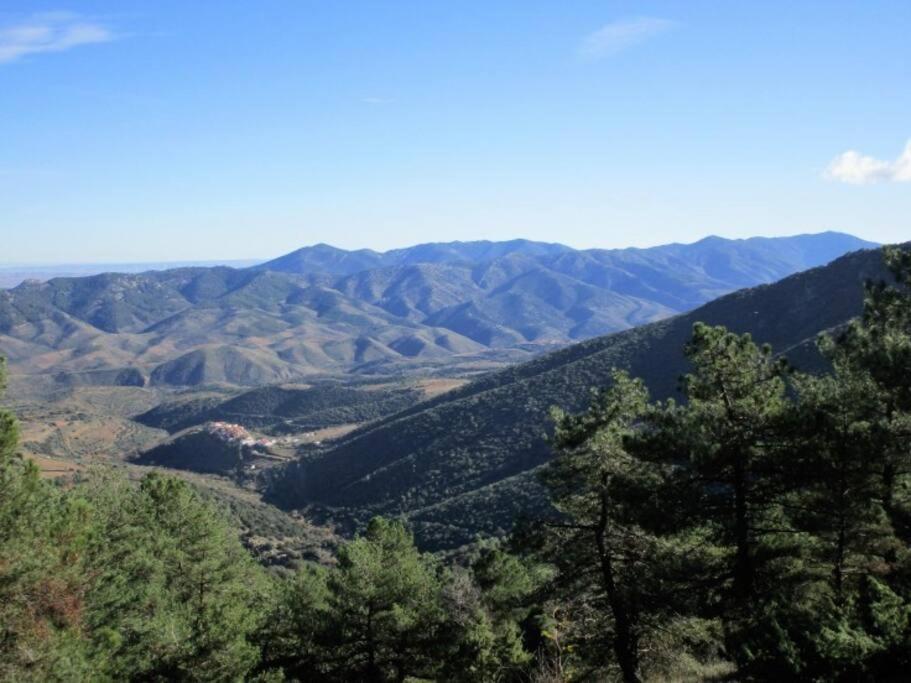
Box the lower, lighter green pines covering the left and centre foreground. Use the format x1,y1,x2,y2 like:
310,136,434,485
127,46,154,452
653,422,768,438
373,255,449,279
0,360,532,682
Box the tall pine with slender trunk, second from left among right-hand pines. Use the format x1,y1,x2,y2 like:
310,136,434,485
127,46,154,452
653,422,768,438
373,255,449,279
671,323,788,605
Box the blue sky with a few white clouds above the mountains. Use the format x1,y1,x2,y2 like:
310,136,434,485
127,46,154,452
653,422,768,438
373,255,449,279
0,0,911,263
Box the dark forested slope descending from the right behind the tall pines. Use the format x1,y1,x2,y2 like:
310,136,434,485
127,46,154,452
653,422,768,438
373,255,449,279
269,250,888,549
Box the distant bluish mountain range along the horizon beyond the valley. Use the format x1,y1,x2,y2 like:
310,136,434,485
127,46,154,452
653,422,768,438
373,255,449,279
0,232,872,386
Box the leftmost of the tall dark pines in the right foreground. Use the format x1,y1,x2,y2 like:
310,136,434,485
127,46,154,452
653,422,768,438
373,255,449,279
543,372,724,681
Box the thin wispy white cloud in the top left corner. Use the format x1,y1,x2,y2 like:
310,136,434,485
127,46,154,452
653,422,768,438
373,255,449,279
0,12,115,64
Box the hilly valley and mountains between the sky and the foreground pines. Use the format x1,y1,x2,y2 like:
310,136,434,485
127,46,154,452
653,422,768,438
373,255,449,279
0,234,882,550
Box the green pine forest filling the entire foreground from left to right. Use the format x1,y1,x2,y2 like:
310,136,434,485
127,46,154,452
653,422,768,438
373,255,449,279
0,248,911,683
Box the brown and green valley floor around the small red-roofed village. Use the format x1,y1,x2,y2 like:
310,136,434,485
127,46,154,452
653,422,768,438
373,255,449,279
4,376,467,567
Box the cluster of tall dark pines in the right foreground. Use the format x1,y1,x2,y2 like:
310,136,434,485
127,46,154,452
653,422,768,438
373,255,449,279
539,248,911,681
